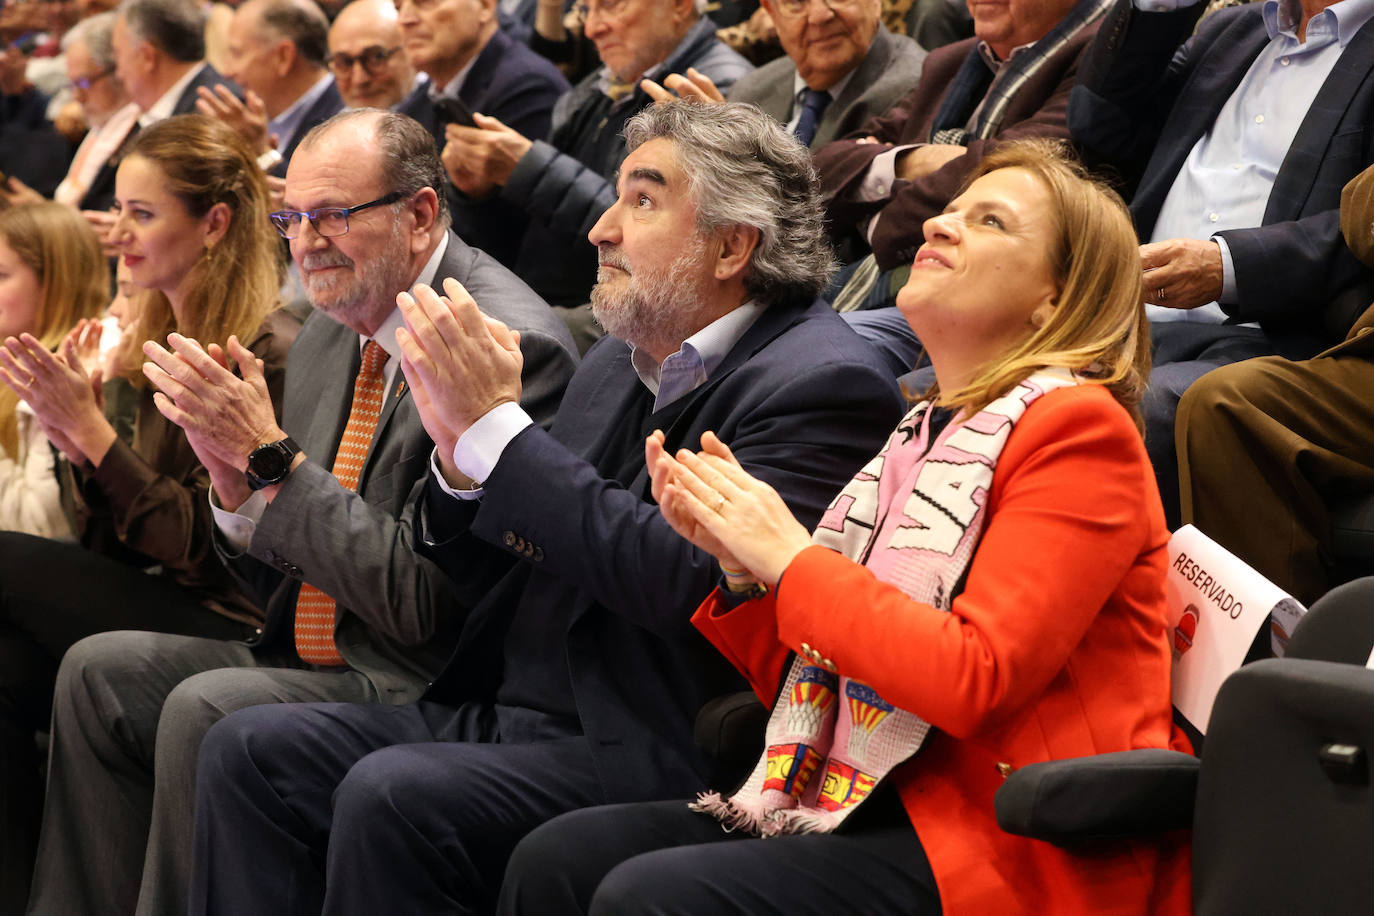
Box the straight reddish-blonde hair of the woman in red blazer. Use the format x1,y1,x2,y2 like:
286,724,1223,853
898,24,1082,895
930,140,1150,428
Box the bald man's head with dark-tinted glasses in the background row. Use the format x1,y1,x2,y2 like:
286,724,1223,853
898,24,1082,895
330,0,429,117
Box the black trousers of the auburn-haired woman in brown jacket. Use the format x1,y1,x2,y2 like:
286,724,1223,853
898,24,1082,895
0,531,251,913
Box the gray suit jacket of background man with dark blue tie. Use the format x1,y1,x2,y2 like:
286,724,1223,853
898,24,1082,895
728,25,926,150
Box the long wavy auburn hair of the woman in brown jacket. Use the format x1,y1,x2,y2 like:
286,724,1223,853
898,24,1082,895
118,114,284,387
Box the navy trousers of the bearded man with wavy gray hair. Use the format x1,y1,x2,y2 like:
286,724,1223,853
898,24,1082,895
190,702,605,915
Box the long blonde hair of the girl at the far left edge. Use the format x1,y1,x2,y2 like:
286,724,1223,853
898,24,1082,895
0,201,110,457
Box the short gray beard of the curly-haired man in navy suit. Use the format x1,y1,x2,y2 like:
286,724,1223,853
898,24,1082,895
592,239,708,353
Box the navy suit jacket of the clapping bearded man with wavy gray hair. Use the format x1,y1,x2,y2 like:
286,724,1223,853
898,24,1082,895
416,302,903,802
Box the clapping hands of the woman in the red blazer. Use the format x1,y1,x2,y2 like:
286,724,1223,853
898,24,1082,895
646,433,811,588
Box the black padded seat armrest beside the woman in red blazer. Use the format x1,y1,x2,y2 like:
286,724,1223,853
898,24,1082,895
995,748,1200,845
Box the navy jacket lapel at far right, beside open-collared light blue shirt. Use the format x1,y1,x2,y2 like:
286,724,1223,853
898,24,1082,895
1264,21,1374,225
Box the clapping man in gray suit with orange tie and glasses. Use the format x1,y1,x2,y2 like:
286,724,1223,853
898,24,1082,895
32,110,574,915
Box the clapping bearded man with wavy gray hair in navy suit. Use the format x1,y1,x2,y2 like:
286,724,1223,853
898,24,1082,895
191,102,901,913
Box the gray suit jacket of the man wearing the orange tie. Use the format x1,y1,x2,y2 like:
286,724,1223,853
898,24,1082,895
216,232,577,703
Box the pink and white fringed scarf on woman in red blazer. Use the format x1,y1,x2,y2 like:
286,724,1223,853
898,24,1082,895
692,369,1076,836
